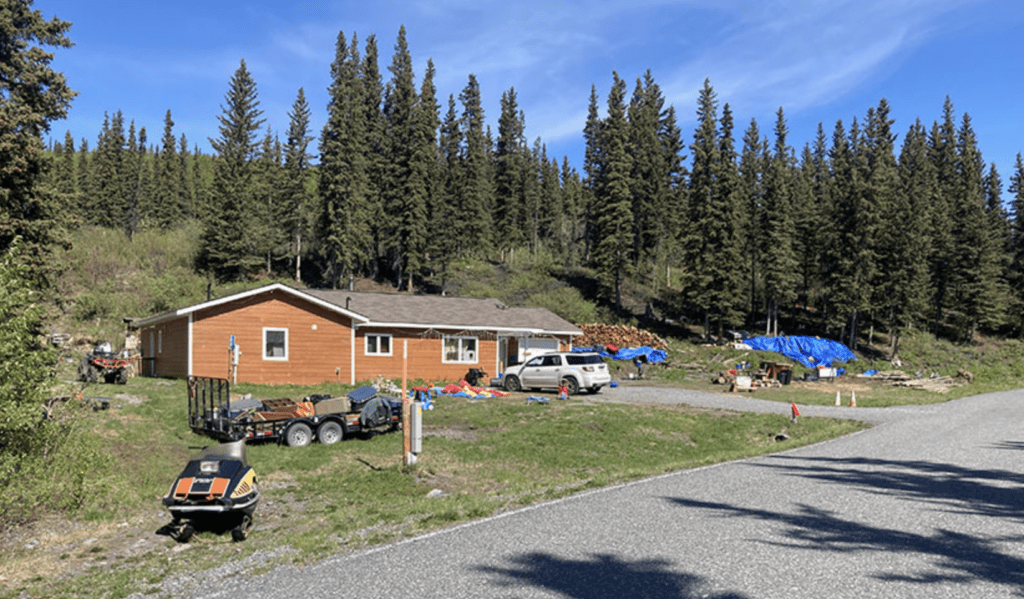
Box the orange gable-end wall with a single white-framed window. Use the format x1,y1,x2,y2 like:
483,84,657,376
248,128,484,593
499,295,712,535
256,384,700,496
193,291,351,385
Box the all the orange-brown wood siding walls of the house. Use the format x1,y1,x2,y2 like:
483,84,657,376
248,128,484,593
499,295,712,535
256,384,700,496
139,290,570,385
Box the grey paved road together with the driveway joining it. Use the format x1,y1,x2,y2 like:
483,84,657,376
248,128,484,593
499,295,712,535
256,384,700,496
178,387,1024,599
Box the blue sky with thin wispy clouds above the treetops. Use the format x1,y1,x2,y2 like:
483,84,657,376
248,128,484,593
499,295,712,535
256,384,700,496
44,0,1024,183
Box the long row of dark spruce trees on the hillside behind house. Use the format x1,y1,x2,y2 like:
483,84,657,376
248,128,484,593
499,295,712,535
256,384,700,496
49,28,1024,351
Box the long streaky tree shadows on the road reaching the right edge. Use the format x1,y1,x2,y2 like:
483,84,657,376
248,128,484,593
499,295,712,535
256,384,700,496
666,456,1024,593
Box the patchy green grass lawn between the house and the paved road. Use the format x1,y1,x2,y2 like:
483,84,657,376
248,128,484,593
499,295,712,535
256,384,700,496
0,372,864,598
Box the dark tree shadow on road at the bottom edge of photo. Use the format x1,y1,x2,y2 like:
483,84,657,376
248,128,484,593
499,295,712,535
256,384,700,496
476,553,748,599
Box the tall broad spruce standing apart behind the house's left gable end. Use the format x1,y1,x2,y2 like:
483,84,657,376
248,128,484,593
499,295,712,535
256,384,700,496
199,59,263,282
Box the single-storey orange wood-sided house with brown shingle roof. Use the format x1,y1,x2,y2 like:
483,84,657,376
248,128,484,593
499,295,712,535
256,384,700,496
135,284,583,385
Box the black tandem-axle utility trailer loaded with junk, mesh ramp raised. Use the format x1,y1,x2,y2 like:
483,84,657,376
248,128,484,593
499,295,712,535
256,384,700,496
188,377,401,447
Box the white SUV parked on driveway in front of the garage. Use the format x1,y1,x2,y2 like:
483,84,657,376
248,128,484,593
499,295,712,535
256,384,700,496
502,351,611,395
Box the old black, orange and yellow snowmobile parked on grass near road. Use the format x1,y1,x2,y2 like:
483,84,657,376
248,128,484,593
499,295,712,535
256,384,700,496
162,440,259,543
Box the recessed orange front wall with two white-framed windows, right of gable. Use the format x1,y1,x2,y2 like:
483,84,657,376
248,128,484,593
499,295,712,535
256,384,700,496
355,327,498,383
